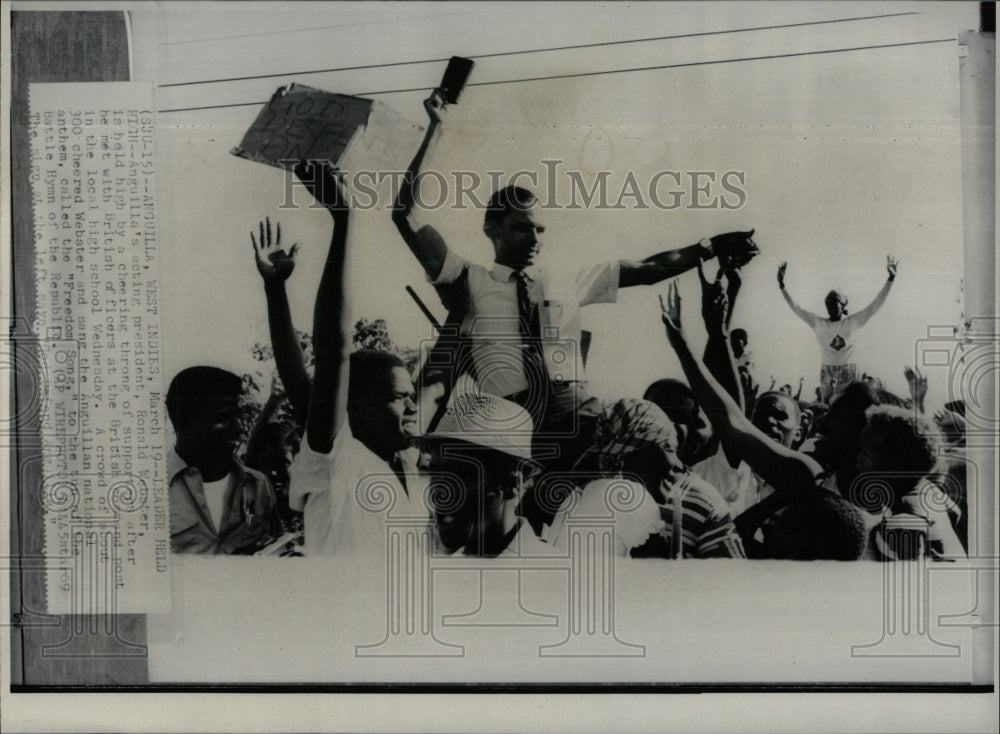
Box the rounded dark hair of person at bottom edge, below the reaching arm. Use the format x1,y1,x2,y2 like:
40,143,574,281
772,490,867,561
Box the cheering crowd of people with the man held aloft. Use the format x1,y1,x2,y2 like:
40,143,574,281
167,92,968,561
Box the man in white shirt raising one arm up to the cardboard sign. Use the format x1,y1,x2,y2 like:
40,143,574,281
289,162,429,558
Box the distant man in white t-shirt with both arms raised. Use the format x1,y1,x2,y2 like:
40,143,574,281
778,255,899,403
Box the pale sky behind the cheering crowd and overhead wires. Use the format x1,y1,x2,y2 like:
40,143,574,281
132,2,978,405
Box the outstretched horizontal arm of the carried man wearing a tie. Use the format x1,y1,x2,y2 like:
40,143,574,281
618,229,760,288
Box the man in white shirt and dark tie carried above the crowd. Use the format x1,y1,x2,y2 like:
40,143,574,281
393,91,758,530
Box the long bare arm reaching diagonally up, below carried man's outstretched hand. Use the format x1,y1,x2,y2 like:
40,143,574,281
660,283,822,492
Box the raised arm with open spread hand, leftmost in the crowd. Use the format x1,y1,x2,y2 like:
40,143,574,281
250,217,312,431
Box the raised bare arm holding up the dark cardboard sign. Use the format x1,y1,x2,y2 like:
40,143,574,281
295,161,351,454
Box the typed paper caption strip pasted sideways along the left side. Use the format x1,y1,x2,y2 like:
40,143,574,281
30,83,170,614
